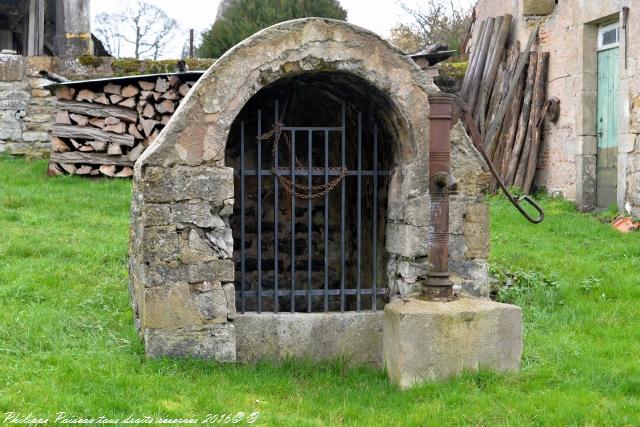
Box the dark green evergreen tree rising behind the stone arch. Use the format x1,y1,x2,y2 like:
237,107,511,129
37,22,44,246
198,0,347,58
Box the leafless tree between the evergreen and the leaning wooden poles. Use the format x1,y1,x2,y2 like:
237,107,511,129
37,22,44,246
391,0,471,53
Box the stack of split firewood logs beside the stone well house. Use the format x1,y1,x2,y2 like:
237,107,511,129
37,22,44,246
49,75,195,178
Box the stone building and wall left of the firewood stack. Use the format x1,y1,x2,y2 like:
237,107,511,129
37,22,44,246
0,0,93,156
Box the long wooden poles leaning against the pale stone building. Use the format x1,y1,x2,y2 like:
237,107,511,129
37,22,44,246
460,15,549,194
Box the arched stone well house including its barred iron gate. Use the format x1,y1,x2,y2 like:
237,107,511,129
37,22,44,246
129,18,489,365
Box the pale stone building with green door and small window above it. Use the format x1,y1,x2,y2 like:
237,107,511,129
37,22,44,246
470,0,640,216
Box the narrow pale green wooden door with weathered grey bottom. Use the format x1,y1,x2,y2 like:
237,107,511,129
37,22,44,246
596,47,619,207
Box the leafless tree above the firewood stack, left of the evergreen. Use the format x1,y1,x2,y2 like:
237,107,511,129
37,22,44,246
96,0,178,59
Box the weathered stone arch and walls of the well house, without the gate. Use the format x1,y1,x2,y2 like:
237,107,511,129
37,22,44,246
129,18,489,361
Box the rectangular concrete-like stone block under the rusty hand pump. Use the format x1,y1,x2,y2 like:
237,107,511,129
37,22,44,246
383,298,522,389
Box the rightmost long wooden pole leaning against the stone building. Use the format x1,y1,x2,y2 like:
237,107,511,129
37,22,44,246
522,52,549,194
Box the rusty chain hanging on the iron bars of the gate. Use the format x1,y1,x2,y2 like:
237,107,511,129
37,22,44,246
257,121,349,200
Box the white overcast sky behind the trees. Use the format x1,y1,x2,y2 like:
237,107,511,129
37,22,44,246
91,0,473,58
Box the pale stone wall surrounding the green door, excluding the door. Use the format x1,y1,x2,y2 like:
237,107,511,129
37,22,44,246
470,0,640,216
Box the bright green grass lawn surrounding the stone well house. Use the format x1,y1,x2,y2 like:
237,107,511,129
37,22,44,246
0,157,640,426
